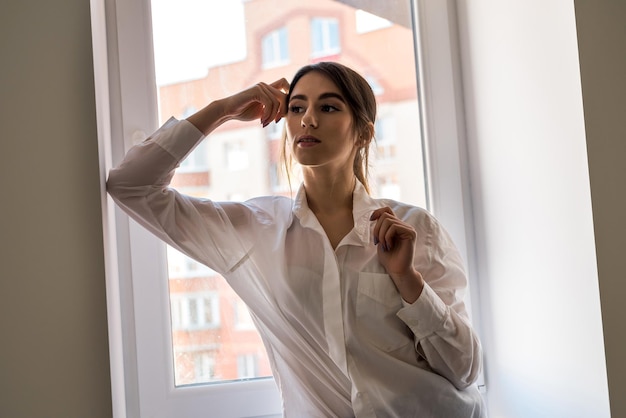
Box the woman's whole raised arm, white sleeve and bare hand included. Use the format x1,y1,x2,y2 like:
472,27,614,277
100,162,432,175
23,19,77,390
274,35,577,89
107,79,289,272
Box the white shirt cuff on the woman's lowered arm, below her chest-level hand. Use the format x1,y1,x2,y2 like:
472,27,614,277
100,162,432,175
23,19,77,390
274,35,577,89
397,284,450,341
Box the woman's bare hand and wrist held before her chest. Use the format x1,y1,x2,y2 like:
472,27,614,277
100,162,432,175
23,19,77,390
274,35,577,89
370,207,424,303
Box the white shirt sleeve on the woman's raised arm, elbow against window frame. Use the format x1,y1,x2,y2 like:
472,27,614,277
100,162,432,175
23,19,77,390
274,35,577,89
107,119,263,273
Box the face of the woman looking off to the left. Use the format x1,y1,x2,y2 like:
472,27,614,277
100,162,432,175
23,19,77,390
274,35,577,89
286,71,357,173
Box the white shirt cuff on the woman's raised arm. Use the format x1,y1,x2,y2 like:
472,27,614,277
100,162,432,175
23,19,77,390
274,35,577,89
148,117,204,161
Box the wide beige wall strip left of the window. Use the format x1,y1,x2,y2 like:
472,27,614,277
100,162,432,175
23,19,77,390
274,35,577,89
0,0,111,418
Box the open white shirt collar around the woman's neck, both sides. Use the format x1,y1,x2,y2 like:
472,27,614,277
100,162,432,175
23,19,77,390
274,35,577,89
293,180,384,245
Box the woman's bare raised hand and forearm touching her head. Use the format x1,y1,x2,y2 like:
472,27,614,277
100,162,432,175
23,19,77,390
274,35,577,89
187,78,289,135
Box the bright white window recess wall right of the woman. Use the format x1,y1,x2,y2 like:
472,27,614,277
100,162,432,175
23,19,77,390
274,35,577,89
458,0,610,418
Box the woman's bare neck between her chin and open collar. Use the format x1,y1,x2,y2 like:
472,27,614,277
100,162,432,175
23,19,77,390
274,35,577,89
304,173,356,214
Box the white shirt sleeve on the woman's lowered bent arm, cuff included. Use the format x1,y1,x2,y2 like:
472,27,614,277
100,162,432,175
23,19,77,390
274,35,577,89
398,216,482,389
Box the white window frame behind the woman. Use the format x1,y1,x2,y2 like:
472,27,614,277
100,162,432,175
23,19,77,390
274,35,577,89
90,0,480,418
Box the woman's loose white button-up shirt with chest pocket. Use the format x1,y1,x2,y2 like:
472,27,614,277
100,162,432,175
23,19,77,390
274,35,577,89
107,119,485,418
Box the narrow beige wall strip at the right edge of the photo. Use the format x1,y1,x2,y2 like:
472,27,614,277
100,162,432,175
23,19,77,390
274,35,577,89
574,0,626,417
